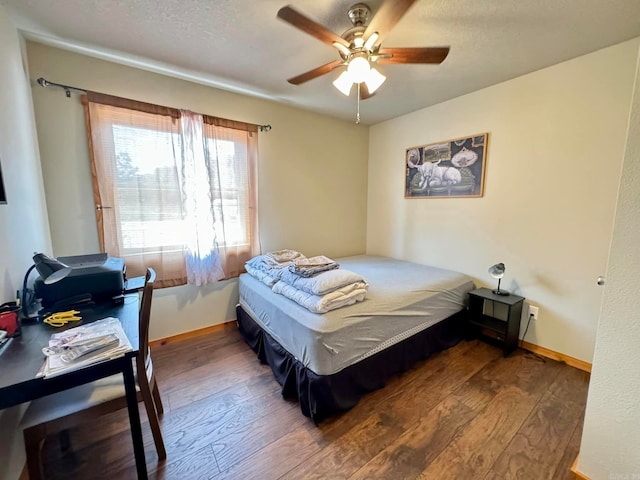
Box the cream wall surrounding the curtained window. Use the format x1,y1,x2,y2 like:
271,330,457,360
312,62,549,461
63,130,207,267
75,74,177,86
28,42,368,339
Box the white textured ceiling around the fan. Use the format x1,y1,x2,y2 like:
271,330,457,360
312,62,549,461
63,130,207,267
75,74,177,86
0,0,640,124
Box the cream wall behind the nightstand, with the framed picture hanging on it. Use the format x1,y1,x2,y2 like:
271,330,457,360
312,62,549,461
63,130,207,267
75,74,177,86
367,39,640,362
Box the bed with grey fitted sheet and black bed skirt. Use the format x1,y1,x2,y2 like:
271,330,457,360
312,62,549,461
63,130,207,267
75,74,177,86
237,255,473,422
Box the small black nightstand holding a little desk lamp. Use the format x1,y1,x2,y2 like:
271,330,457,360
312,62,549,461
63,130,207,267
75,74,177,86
469,288,524,357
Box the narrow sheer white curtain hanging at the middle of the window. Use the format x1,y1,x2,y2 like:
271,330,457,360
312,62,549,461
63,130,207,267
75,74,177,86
177,110,226,285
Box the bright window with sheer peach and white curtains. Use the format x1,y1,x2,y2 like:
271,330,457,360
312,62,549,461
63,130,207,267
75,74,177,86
85,93,257,286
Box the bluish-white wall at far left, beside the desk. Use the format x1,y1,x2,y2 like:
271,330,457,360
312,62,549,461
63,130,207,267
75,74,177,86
0,5,51,479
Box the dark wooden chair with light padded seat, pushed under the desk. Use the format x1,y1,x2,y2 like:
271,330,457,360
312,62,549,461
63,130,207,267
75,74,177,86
22,268,167,480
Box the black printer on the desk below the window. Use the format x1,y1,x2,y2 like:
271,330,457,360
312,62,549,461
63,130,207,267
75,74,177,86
33,253,126,309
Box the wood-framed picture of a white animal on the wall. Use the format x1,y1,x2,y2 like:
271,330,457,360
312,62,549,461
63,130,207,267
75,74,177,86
404,133,489,198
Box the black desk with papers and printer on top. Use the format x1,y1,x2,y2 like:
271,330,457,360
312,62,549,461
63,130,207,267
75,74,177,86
0,294,147,479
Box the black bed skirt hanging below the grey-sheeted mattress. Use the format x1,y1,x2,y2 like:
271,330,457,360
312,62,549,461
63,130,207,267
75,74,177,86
236,305,466,423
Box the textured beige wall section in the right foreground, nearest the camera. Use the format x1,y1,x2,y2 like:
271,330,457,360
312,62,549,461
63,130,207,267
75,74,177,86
578,46,640,480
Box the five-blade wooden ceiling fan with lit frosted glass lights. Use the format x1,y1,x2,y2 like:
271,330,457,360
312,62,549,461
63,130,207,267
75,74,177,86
278,0,449,100
